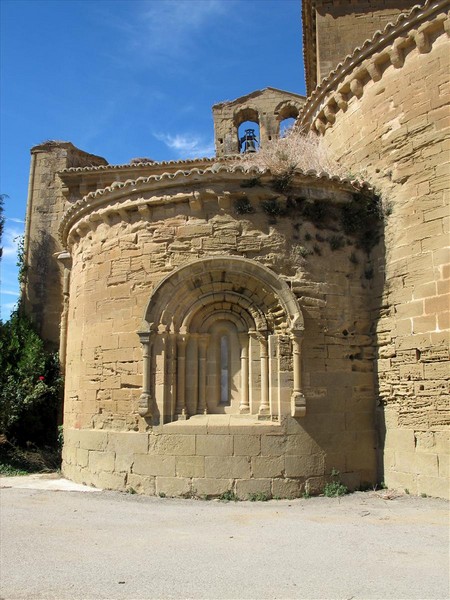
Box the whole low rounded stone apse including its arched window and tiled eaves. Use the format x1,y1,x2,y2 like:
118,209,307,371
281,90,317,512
61,165,383,499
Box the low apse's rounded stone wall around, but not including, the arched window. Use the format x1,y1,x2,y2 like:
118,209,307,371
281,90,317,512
63,176,382,497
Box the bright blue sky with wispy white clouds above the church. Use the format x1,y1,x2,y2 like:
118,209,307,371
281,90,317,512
0,0,305,320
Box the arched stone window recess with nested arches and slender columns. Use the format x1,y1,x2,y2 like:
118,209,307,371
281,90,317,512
139,257,305,422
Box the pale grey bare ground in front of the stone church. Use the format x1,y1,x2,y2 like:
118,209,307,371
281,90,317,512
0,476,450,600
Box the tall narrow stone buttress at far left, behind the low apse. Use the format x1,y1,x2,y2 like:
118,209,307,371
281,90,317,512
23,142,106,348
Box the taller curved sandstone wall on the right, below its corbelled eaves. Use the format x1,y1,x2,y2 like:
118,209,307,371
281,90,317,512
316,22,450,497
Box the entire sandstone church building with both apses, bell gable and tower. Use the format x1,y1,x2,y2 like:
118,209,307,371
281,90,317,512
22,0,450,498
